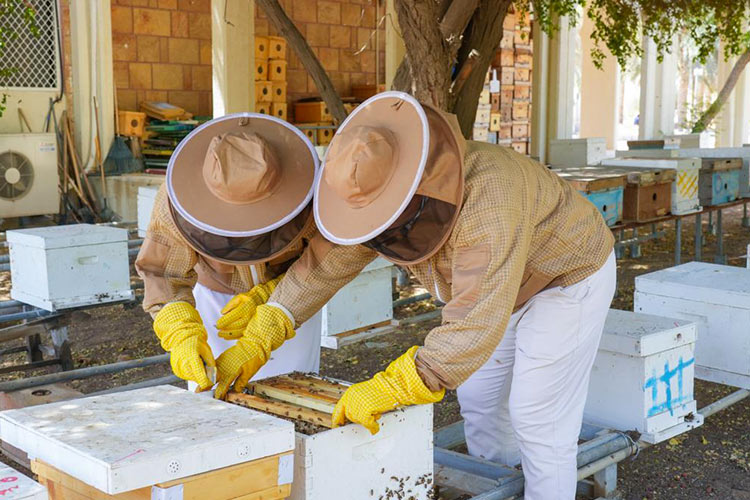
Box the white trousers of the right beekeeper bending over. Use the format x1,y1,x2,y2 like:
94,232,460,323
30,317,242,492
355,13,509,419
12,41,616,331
458,252,617,500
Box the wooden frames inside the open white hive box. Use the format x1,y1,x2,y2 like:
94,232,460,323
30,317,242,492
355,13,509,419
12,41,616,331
227,374,347,428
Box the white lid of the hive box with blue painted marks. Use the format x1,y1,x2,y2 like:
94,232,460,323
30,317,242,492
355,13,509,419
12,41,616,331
599,309,696,356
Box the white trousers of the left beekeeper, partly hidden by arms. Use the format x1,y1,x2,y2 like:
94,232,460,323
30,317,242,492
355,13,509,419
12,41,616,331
188,284,322,391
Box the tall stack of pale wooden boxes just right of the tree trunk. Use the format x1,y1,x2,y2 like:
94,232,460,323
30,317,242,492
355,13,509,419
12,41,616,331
473,9,532,154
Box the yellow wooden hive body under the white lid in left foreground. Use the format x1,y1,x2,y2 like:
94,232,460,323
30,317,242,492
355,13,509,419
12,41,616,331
31,452,292,500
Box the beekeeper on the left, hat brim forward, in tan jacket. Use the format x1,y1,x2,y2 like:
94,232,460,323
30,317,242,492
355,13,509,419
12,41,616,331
135,113,320,390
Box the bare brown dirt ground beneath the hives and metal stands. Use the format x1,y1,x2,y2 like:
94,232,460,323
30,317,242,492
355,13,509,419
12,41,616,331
0,207,750,500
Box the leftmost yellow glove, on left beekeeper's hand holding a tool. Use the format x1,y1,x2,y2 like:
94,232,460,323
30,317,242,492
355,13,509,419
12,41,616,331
154,302,216,391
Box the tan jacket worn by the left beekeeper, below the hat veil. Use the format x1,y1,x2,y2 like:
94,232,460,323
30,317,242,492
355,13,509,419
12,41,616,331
135,185,315,316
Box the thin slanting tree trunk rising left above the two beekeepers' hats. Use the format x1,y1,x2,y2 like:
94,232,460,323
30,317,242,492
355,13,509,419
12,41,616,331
256,0,346,123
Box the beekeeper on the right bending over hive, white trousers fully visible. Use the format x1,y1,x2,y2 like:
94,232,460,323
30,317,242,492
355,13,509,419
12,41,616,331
216,92,616,500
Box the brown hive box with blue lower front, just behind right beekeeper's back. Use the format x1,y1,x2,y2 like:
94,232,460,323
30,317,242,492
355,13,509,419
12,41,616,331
555,167,625,226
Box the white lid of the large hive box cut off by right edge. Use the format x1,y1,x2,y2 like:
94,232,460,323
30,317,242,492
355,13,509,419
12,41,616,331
635,262,750,309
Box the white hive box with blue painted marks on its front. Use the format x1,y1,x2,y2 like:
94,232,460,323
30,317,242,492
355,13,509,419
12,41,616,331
584,309,703,443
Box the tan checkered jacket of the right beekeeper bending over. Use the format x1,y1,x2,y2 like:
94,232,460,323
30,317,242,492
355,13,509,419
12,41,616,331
269,142,614,390
